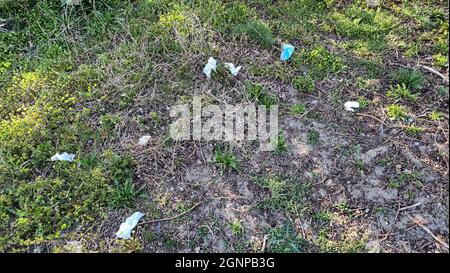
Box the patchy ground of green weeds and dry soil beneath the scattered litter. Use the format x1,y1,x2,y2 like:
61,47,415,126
0,0,449,252
